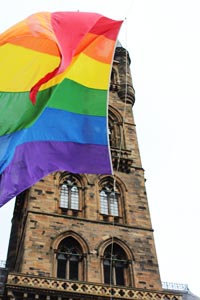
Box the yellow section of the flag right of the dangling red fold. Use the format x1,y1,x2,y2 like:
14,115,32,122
42,53,110,90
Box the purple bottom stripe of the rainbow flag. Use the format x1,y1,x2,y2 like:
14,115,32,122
0,142,112,207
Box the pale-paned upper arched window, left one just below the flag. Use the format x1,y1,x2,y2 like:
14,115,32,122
60,174,79,210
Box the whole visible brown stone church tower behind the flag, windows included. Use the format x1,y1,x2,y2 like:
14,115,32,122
0,45,181,300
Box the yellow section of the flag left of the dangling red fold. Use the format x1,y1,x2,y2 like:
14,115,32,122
0,43,60,92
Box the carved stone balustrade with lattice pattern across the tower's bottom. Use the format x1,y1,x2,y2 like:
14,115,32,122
3,273,182,300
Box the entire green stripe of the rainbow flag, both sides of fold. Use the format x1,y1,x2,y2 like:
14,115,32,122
0,79,107,136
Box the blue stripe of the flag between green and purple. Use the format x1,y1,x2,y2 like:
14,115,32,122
0,108,108,173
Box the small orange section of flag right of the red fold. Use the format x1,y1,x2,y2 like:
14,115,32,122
75,33,115,64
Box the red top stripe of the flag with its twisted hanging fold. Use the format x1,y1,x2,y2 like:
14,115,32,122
30,12,122,103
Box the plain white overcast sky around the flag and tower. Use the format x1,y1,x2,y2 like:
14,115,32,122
0,0,200,296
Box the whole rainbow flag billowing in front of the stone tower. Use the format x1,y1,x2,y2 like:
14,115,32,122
0,12,122,206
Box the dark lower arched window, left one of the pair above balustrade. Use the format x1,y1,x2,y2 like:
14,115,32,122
56,237,83,280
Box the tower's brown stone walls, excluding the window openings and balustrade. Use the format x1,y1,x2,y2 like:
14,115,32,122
7,48,162,291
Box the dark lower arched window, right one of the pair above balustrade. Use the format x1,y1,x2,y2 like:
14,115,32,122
103,243,129,285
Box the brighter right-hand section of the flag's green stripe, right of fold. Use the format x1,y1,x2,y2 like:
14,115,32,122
48,79,107,116
